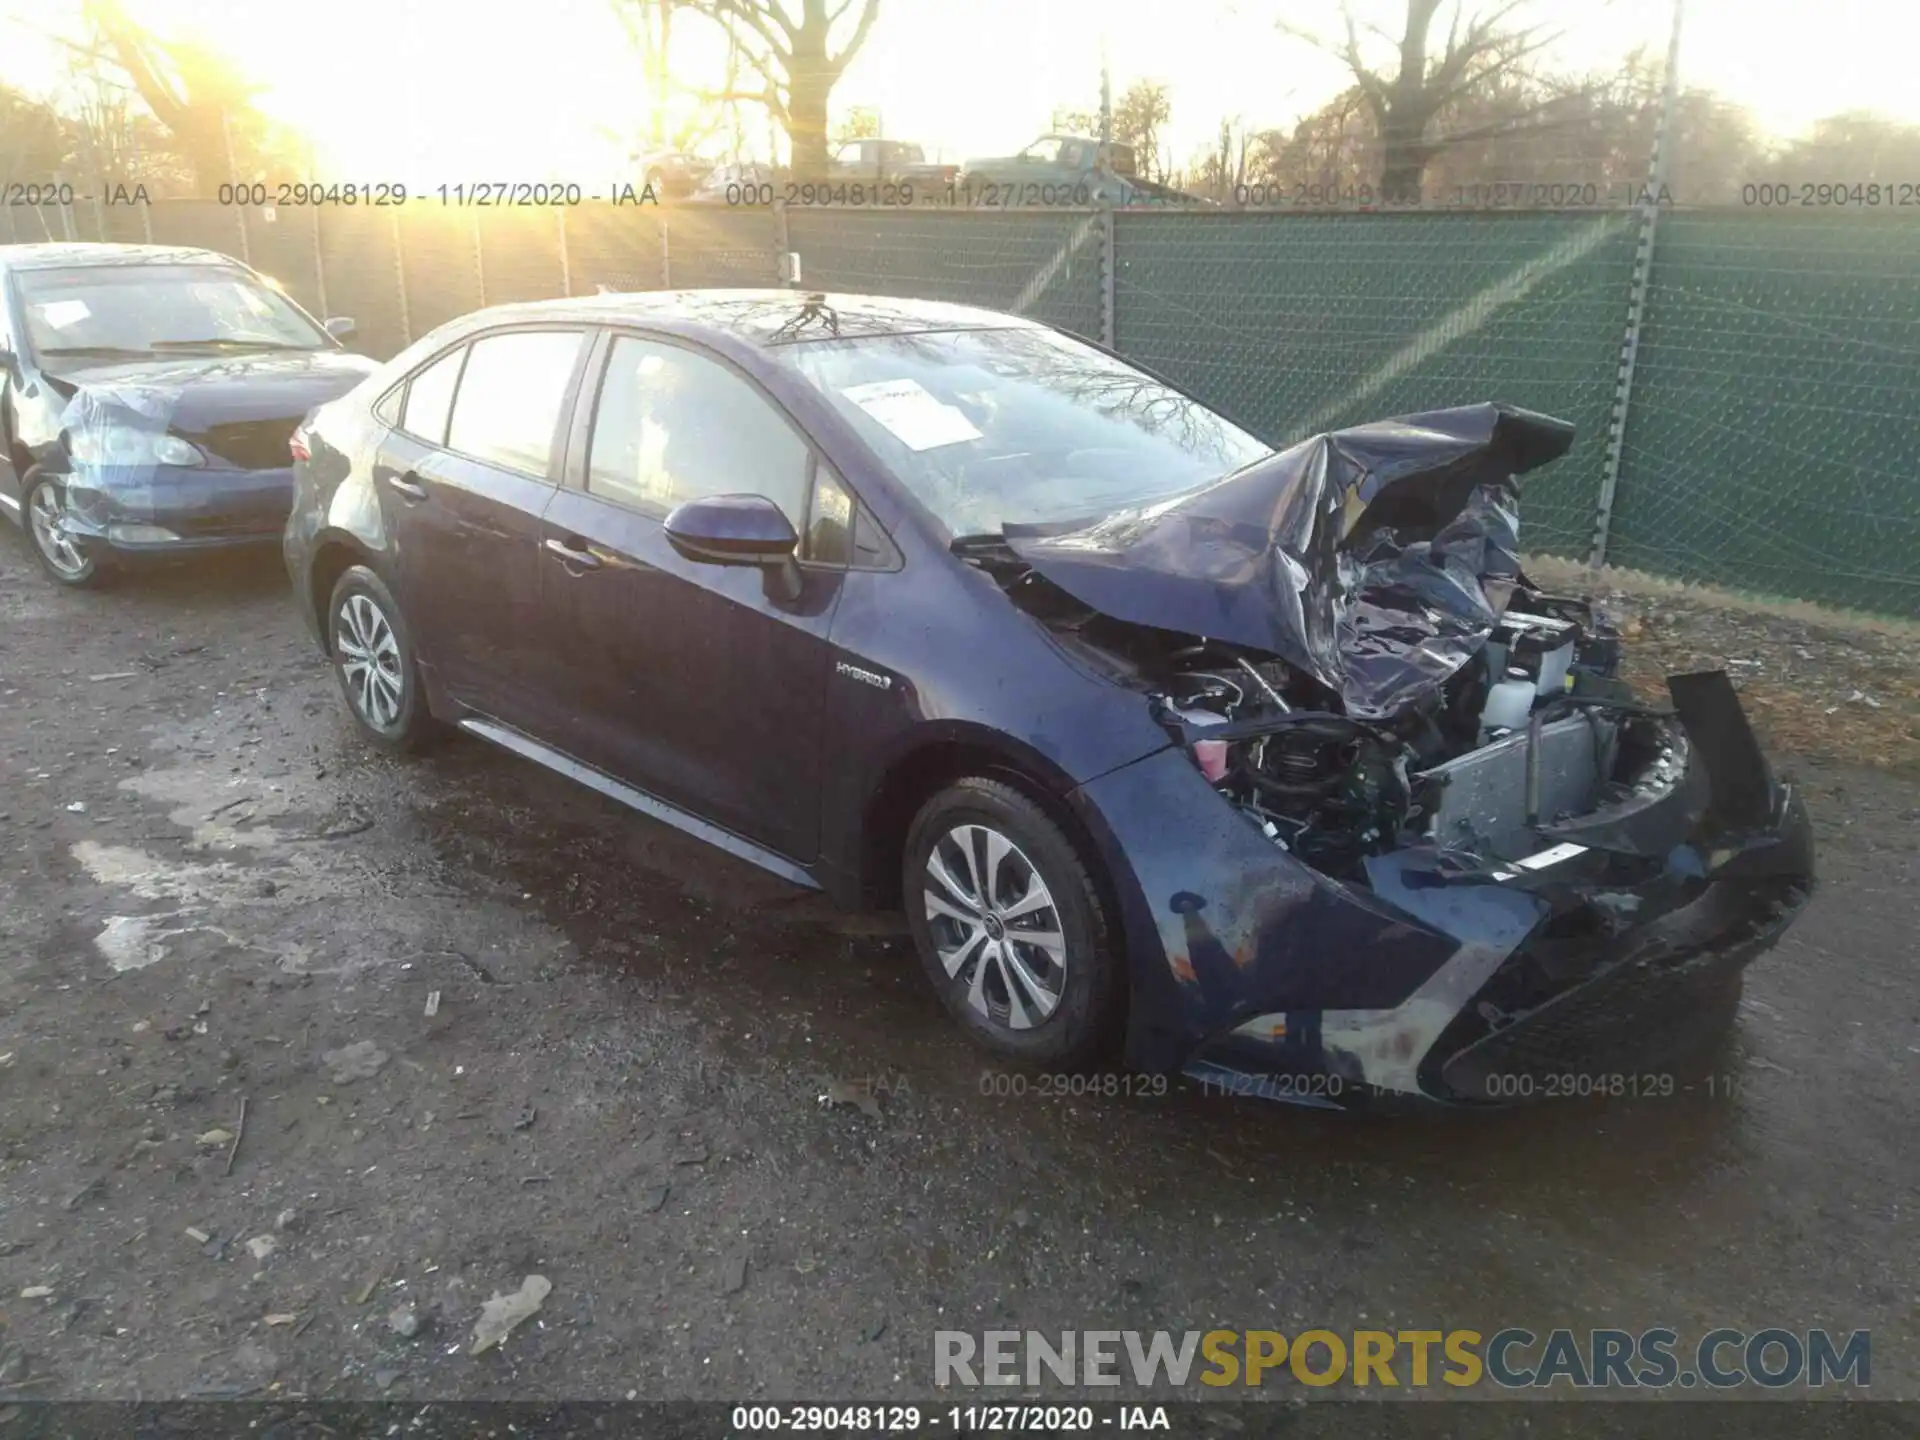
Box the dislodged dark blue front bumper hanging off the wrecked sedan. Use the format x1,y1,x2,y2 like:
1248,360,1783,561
1083,674,1814,1108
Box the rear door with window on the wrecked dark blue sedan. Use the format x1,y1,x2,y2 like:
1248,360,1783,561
374,326,588,733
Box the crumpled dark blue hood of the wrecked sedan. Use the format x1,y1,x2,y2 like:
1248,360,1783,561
1004,403,1572,716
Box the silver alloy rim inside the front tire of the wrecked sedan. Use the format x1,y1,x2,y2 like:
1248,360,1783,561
924,826,1068,1031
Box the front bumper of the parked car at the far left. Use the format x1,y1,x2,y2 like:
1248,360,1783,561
65,467,294,557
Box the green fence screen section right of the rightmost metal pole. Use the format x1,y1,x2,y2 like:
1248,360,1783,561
1609,215,1920,616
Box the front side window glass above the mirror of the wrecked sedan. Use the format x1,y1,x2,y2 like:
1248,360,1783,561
595,336,808,530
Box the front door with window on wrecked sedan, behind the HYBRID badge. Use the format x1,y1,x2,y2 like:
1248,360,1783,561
541,334,845,862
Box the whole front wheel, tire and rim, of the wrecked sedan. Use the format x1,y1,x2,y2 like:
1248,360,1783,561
902,776,1125,1069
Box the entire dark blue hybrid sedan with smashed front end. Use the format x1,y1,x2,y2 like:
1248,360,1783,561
286,292,1812,1106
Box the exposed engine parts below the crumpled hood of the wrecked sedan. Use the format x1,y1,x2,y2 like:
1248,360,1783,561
1160,591,1684,879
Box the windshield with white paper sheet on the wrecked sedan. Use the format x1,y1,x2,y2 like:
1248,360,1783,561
776,326,1273,536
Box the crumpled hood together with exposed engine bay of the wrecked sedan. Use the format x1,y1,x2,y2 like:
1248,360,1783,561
956,405,1688,883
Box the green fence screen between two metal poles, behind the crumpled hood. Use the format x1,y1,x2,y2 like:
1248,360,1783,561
1114,213,1634,568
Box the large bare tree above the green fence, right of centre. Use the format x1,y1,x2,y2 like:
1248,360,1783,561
1281,0,1567,204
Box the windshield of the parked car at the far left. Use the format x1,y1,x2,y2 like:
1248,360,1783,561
17,265,334,359
